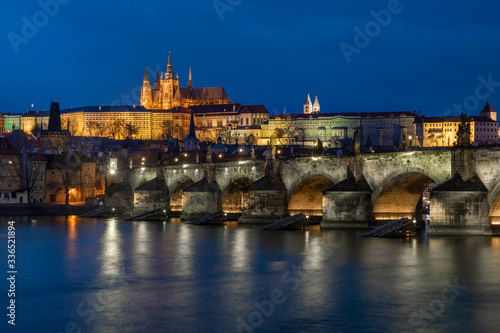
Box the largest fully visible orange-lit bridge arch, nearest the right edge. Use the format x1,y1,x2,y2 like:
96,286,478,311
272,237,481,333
372,168,440,220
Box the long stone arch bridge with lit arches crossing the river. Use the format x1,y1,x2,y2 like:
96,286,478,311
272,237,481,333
120,148,500,235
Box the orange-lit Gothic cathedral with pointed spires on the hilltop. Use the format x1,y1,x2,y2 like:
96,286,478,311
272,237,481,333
141,54,231,109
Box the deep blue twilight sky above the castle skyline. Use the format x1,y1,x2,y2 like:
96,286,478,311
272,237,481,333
0,0,500,115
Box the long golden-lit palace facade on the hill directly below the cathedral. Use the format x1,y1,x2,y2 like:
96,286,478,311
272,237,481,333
57,103,269,142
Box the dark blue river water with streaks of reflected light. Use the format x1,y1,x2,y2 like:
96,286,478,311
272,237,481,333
0,216,500,333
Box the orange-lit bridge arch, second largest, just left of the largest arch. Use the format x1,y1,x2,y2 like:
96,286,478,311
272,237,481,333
288,172,334,216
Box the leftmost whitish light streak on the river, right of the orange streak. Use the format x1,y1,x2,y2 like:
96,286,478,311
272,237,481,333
99,219,123,277
